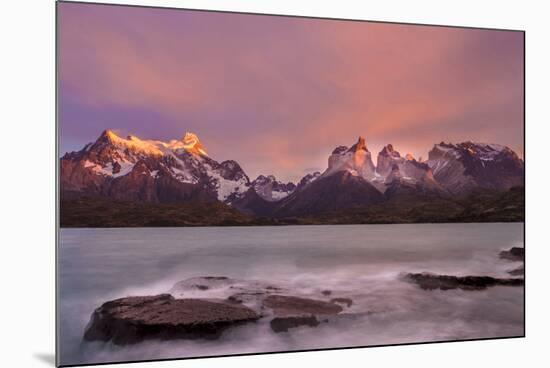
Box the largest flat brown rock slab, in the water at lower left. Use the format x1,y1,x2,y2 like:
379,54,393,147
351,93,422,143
84,294,261,345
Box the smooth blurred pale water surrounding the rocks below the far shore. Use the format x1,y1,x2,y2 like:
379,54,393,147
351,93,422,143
58,223,524,364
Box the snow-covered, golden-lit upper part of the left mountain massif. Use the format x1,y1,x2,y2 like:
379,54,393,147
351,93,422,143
63,130,249,201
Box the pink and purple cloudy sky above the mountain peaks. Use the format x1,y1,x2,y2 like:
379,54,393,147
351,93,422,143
58,3,524,180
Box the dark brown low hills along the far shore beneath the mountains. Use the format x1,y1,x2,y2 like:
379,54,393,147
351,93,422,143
60,187,525,228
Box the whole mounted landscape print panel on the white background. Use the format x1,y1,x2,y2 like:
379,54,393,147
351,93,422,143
57,2,525,366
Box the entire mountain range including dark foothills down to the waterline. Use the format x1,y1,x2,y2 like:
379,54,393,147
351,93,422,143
60,130,524,226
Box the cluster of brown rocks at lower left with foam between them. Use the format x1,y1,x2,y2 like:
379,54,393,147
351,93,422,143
84,276,358,345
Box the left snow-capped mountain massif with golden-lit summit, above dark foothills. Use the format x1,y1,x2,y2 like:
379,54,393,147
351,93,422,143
60,130,249,203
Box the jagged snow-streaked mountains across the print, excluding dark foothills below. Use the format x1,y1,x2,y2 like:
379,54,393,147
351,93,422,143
60,130,524,224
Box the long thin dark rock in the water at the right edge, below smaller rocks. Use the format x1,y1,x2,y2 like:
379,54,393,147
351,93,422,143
405,273,524,290
